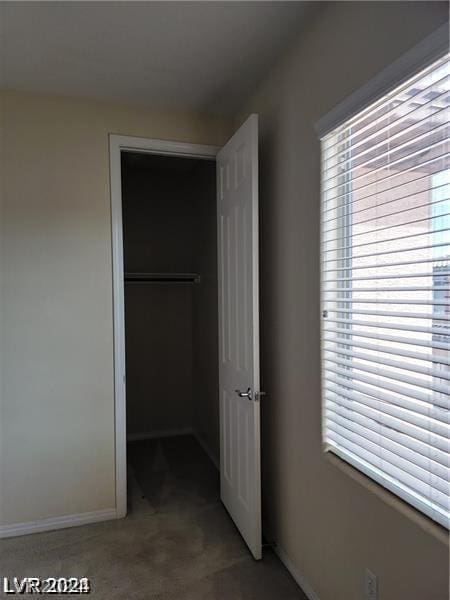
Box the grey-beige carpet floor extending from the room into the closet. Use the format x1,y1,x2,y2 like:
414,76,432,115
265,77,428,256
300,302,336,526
0,436,306,600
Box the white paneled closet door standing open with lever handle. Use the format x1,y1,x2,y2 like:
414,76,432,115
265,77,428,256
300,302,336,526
217,115,261,559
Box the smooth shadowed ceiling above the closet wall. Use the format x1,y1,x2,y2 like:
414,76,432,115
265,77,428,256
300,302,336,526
0,1,313,115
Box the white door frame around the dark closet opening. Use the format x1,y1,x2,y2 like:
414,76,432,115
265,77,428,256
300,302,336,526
109,134,220,519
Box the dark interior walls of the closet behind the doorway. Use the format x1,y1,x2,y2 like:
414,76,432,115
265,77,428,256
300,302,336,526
122,153,218,454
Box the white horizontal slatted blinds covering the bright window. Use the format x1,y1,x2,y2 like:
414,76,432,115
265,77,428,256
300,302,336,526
321,55,450,528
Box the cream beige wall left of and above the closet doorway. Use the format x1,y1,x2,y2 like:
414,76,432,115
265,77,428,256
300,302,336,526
0,92,229,525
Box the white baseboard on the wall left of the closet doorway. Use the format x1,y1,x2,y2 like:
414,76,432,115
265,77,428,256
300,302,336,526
0,508,117,539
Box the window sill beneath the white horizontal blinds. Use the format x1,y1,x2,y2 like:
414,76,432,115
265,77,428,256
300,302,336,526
324,452,450,548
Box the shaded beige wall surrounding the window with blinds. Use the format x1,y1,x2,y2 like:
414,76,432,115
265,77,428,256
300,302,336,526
237,2,448,600
